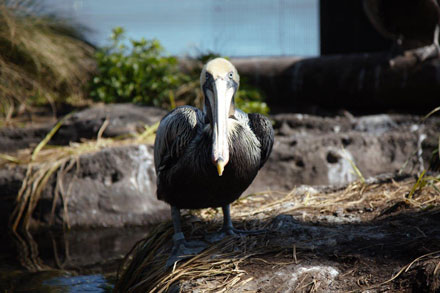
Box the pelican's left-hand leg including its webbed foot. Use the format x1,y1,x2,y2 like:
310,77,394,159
165,206,206,268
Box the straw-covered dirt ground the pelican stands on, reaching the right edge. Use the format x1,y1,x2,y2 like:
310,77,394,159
116,177,440,292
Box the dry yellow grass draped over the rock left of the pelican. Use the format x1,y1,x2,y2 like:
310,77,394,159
4,116,158,231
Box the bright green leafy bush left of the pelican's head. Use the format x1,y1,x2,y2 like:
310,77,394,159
90,27,183,107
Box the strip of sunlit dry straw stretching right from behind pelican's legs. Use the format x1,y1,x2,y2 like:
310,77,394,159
235,173,440,218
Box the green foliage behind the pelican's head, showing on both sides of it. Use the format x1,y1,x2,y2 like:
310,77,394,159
90,27,269,114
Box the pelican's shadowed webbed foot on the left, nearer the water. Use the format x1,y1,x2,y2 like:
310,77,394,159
165,232,207,268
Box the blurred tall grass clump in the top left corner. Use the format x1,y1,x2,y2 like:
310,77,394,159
0,0,95,119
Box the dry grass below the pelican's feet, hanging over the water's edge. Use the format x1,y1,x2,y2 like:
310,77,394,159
115,223,285,292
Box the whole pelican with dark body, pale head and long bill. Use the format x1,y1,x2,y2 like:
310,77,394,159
154,58,274,262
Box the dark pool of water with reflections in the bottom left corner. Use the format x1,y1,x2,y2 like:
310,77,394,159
0,227,148,292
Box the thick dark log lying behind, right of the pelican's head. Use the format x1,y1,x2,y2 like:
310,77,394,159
233,50,440,113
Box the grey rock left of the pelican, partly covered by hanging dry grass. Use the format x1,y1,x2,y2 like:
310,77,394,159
0,145,169,227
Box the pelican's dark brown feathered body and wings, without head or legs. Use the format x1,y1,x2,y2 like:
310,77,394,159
156,106,273,209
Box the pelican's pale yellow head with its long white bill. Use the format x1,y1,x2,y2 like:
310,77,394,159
200,58,240,176
